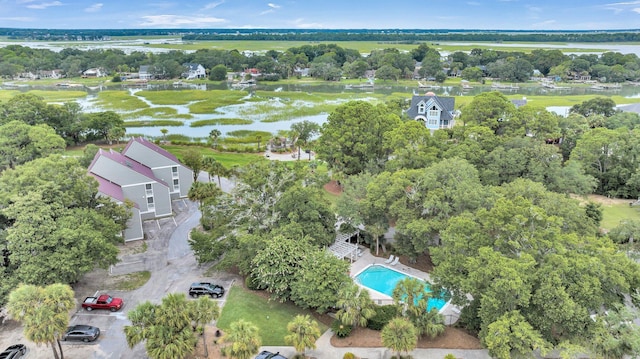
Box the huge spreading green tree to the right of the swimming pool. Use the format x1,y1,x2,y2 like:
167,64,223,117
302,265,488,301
431,180,640,355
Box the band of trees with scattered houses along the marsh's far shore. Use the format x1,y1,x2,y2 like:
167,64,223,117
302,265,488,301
5,43,640,82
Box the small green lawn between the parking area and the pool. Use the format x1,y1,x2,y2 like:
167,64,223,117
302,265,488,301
217,285,328,346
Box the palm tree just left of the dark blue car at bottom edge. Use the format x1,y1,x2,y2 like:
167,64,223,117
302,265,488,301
220,319,262,359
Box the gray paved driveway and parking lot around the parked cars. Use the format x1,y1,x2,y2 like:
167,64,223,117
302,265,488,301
0,200,239,359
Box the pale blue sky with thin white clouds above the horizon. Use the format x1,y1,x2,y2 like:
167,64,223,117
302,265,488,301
0,0,640,30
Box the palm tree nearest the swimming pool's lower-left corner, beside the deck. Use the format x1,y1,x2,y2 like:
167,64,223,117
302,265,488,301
336,283,375,327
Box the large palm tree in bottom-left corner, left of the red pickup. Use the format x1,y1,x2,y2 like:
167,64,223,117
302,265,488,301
7,283,75,359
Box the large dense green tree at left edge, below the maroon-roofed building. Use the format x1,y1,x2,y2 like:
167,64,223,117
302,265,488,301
0,155,122,301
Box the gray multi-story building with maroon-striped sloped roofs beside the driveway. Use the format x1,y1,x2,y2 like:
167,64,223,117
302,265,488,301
89,137,193,241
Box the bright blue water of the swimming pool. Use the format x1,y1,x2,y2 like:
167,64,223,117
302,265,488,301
356,265,447,311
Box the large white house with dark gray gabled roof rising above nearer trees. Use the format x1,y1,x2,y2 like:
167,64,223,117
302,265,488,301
407,92,456,131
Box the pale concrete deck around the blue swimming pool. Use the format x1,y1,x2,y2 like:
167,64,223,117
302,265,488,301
350,248,461,325
